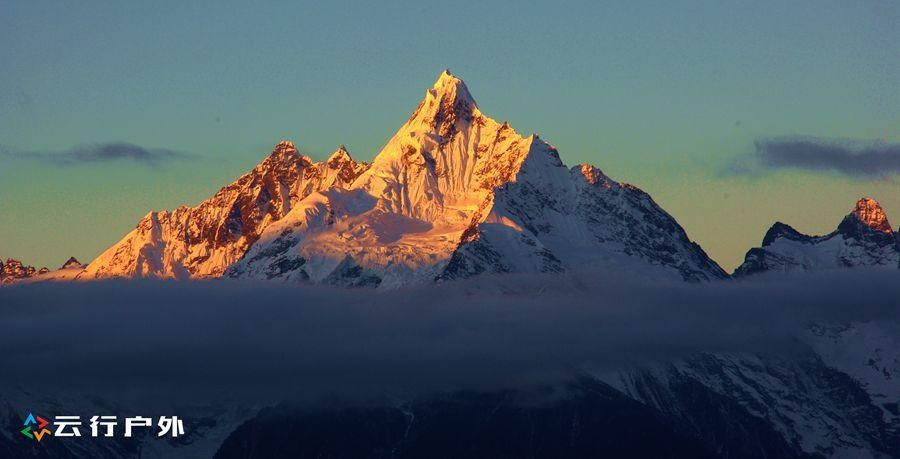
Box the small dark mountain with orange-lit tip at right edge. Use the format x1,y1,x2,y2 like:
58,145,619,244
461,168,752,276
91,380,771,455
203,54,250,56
734,198,900,277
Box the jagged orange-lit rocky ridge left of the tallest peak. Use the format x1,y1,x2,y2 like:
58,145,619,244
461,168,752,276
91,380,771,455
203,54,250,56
80,142,368,279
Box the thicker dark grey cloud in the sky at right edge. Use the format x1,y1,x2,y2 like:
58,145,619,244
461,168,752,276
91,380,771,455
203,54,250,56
725,137,900,178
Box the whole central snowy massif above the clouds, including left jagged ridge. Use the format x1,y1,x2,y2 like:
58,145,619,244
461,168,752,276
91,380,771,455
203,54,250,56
82,71,727,286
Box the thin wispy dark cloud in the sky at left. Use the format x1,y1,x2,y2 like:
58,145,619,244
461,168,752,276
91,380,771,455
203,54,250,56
0,142,196,167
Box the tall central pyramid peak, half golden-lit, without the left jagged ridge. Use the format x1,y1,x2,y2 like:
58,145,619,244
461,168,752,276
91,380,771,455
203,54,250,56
226,72,726,286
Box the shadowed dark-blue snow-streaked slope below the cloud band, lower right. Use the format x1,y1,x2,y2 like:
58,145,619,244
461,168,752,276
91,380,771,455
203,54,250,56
602,320,900,458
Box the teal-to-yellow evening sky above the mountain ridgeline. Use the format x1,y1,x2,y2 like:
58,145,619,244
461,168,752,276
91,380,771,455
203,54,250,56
0,0,900,270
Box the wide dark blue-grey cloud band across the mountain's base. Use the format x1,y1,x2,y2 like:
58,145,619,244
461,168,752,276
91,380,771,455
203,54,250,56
0,271,900,404
